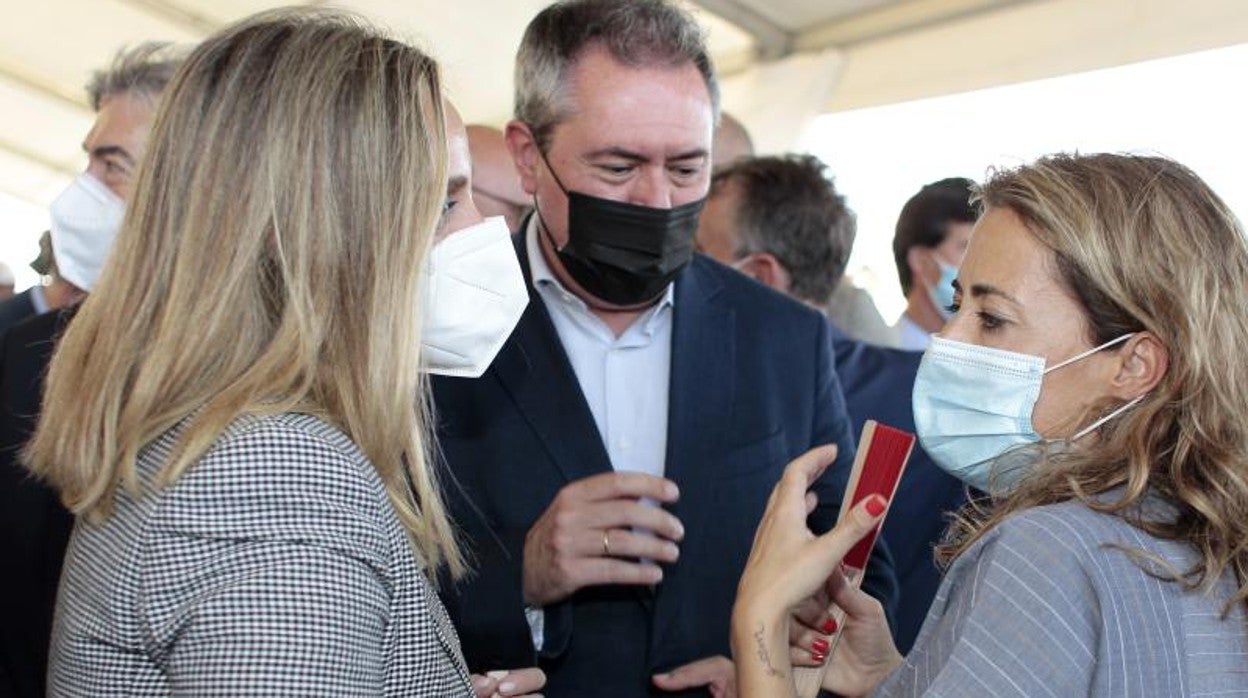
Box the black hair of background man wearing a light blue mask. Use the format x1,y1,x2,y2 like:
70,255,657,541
892,177,980,295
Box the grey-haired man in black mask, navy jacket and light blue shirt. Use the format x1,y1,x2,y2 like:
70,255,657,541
433,0,895,697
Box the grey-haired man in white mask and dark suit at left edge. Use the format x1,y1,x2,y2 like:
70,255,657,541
0,44,180,697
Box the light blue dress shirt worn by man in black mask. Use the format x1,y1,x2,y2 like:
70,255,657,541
524,222,675,652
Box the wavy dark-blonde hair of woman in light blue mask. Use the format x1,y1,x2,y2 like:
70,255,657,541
938,155,1248,612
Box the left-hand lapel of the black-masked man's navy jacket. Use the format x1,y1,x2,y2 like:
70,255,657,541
492,233,612,482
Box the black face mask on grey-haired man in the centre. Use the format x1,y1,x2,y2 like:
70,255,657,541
538,154,706,306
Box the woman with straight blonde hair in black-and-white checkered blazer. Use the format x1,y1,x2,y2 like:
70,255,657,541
27,11,540,696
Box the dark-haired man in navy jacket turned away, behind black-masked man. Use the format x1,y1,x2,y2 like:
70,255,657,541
698,155,966,653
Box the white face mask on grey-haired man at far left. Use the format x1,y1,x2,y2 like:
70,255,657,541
50,172,126,291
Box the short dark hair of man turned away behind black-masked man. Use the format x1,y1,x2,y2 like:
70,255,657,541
711,155,857,306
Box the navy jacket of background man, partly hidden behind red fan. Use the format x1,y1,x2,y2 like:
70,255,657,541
832,327,966,654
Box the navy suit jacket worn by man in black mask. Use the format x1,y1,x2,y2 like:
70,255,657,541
433,240,896,698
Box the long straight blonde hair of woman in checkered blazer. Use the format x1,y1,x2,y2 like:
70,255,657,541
25,10,464,574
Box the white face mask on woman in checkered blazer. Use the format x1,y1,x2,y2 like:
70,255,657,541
421,216,529,378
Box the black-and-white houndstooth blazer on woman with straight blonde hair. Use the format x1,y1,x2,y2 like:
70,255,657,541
49,415,473,697
